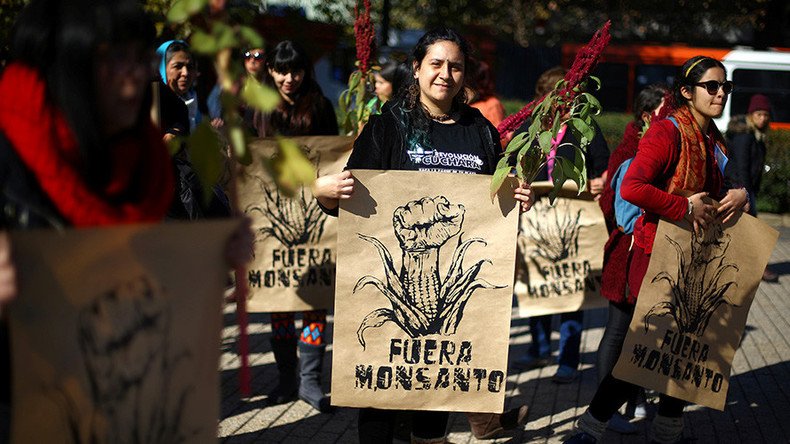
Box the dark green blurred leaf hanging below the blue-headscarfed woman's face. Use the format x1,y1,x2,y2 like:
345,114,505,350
187,121,224,204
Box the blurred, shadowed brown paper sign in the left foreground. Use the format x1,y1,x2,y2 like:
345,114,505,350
9,221,238,443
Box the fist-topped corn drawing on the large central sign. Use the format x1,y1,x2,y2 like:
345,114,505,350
353,196,506,348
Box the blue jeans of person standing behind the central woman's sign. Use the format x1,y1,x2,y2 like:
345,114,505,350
529,311,584,368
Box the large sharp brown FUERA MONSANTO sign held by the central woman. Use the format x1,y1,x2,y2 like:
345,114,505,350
332,170,518,412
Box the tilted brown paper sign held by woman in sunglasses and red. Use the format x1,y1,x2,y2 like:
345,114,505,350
613,214,779,410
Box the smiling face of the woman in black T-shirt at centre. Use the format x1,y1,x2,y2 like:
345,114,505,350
414,40,464,110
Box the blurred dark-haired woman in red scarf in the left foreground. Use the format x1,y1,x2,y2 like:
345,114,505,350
0,0,253,442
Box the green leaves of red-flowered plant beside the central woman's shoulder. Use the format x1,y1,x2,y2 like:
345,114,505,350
491,77,601,202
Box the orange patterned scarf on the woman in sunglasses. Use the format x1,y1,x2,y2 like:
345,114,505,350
667,106,726,196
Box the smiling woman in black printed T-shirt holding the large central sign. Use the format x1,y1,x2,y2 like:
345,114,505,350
313,28,532,443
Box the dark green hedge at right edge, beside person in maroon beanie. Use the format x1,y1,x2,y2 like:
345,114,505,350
757,130,790,213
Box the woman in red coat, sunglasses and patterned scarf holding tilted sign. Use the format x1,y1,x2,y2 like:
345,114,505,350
565,56,748,443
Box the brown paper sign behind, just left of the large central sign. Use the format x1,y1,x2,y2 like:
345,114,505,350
238,136,354,312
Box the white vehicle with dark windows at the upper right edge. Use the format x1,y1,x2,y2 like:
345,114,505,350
714,49,790,131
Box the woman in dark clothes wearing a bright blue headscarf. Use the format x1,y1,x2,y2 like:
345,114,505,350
156,40,230,220
